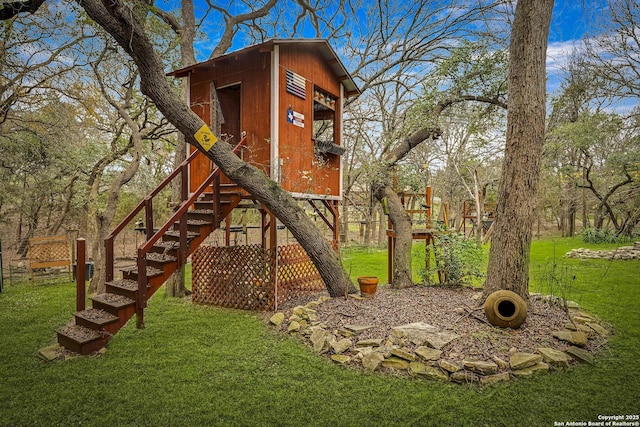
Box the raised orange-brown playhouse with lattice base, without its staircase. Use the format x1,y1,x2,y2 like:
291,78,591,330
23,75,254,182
171,39,359,309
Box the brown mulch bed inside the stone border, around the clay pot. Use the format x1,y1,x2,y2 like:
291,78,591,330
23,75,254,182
272,286,606,362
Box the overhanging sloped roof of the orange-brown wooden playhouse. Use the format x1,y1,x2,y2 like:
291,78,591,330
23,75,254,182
167,38,361,96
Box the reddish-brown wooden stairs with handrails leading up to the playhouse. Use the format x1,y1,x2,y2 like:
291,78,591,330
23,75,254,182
57,139,247,355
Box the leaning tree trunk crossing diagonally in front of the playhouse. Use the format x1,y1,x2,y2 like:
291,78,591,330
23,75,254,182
79,0,351,296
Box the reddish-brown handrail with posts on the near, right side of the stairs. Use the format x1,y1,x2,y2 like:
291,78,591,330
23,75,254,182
137,137,246,318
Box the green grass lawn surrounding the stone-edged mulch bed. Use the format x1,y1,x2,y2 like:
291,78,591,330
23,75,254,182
0,239,640,426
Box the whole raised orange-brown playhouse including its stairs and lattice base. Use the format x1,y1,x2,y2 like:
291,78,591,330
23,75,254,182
58,39,359,354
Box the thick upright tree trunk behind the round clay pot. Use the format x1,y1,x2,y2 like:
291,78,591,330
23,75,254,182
484,0,553,299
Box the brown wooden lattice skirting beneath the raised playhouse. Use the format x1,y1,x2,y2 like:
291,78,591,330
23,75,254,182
192,244,325,310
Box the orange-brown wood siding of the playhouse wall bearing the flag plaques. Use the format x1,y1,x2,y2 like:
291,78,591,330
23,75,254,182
278,44,341,196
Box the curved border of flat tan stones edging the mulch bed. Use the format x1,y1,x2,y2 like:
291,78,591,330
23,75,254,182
269,294,610,385
